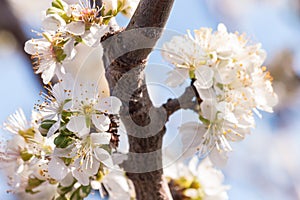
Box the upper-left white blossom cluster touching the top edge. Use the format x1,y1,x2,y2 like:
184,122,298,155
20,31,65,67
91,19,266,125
25,0,139,84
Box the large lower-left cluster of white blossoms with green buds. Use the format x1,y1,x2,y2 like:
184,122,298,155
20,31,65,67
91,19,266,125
1,74,132,199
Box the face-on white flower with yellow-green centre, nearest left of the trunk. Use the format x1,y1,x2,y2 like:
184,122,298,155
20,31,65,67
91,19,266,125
67,83,121,137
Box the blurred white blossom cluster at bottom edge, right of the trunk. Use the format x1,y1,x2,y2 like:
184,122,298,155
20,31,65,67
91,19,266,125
165,156,229,200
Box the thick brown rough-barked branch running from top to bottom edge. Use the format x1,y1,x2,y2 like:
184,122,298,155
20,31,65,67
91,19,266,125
102,0,174,200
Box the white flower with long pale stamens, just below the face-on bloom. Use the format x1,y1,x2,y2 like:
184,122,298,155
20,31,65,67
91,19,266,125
48,132,113,185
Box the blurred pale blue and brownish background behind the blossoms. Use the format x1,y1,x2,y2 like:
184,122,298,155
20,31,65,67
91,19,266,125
0,0,300,200
